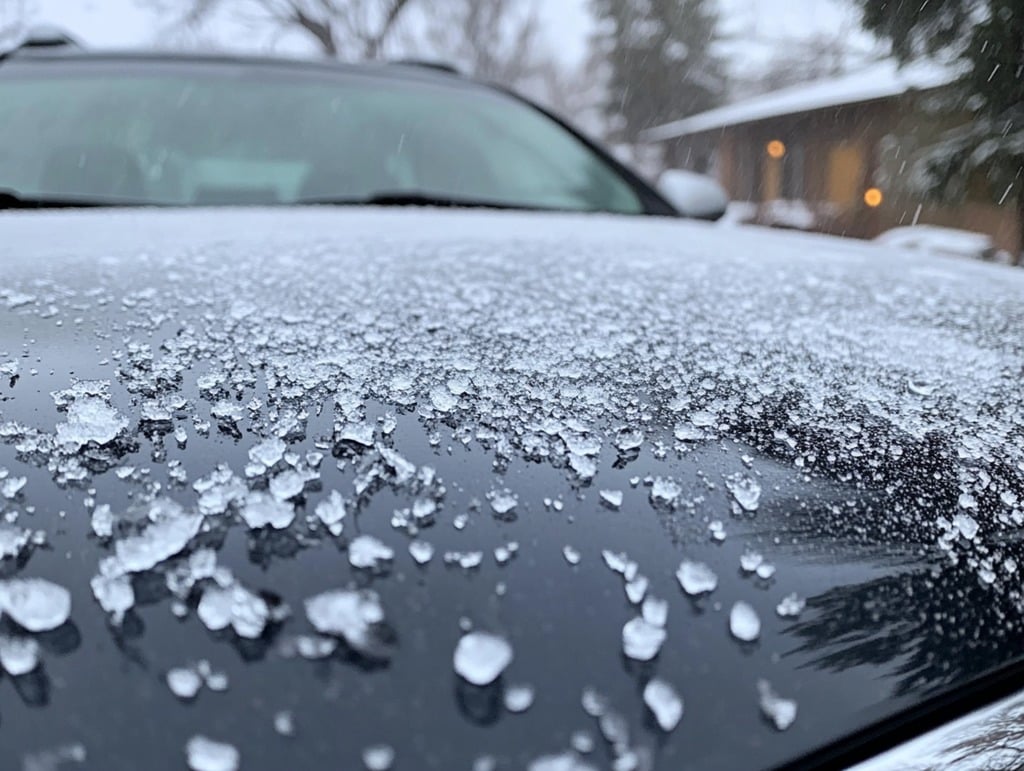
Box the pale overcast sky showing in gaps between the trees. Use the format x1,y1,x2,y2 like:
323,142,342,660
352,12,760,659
25,0,869,73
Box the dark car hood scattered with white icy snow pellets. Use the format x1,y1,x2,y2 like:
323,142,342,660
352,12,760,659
0,205,1024,770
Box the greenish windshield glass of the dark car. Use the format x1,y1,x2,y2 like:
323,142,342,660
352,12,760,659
0,65,642,213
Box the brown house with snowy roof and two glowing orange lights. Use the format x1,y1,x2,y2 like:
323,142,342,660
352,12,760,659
642,60,1022,253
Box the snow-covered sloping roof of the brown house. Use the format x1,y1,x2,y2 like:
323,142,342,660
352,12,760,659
641,59,955,142
